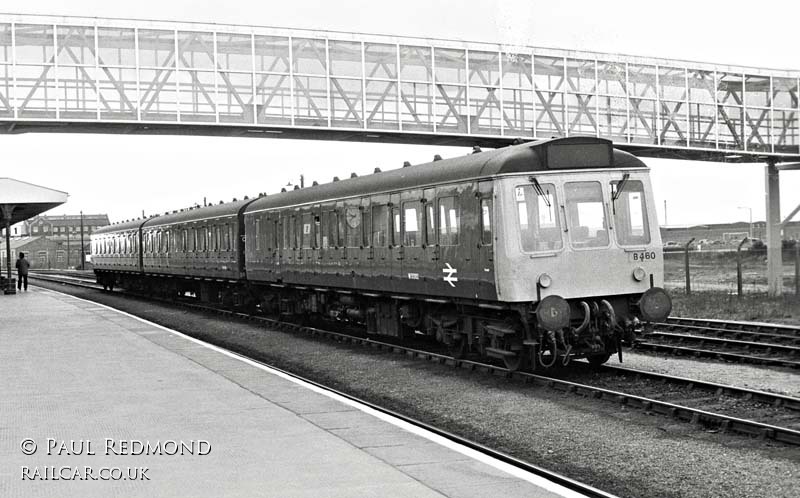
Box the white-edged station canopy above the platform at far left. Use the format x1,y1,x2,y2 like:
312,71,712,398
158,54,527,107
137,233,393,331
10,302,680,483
0,178,67,225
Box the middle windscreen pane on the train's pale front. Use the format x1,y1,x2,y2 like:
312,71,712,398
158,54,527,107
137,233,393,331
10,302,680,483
564,182,608,247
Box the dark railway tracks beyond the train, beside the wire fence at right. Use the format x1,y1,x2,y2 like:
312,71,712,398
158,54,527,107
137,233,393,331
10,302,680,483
634,318,800,368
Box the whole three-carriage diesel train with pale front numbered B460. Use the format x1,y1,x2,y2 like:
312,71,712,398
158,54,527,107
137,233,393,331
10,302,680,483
92,137,671,369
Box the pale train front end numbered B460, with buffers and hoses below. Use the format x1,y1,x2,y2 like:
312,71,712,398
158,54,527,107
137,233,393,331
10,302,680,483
496,167,671,363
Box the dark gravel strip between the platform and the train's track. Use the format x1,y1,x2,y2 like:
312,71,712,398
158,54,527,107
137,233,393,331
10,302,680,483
34,284,800,498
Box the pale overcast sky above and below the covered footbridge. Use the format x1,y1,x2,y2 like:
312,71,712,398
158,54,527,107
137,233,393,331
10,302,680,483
0,0,800,225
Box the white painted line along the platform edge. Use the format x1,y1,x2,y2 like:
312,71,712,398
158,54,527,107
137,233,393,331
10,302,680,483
48,289,613,498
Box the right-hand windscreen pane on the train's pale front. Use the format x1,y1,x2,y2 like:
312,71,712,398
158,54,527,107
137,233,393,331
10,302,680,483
611,180,650,246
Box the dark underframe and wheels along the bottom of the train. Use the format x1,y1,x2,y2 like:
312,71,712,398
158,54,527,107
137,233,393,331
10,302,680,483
97,271,642,371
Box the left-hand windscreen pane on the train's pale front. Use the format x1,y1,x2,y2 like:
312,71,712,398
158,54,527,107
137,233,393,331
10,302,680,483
514,183,563,252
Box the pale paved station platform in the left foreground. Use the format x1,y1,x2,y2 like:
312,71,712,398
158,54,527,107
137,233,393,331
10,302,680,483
0,286,579,497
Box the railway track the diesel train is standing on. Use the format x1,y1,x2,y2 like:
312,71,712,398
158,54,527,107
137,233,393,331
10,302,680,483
31,275,800,445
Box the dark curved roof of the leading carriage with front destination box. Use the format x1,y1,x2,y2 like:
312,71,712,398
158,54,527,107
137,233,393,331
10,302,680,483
245,137,647,213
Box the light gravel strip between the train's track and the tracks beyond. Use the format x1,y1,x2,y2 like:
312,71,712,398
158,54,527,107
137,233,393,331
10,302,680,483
608,351,800,398
